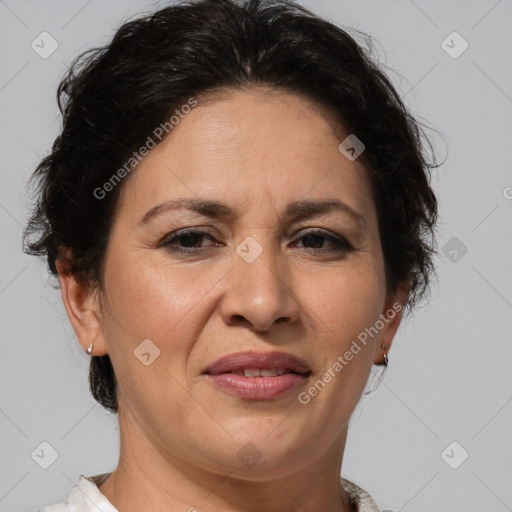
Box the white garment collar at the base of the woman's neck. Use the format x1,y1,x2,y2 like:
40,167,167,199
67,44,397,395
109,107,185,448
38,473,379,512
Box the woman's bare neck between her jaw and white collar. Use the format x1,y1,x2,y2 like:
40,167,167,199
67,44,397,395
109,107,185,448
99,406,353,512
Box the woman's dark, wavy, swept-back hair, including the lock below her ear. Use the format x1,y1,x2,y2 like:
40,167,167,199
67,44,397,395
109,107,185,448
23,0,439,412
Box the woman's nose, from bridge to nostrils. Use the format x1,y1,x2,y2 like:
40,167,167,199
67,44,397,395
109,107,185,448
220,239,300,331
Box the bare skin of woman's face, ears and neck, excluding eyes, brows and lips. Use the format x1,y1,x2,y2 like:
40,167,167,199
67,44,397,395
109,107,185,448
58,88,404,512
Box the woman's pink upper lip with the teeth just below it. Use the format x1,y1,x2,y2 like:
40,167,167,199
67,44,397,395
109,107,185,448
203,352,310,377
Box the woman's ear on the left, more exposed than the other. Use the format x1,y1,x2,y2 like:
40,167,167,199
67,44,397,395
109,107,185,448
55,257,108,356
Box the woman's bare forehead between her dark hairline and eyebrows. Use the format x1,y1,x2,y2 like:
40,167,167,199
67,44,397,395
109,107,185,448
114,89,373,227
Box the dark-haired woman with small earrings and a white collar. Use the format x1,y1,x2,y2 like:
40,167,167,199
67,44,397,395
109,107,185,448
25,0,437,512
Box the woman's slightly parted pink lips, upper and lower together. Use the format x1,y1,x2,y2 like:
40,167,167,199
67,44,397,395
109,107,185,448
204,352,311,400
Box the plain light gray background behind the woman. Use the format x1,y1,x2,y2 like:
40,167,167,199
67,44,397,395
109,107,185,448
0,0,512,512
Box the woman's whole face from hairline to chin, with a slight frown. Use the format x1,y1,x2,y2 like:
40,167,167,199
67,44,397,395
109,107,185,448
89,89,398,479
